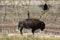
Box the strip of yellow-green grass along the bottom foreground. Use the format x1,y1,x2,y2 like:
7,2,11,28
0,35,60,40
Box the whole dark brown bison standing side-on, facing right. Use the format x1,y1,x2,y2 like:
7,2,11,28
18,19,45,34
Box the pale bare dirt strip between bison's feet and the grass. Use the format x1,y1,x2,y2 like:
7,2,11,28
8,33,60,38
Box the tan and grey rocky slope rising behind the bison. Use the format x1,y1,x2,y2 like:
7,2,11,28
0,0,60,34
